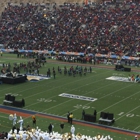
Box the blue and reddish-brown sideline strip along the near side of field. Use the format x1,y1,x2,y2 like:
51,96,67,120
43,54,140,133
0,105,140,137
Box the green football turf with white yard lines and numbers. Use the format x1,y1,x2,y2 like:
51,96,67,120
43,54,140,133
0,54,140,140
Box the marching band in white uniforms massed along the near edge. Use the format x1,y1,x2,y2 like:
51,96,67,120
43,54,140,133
4,114,113,140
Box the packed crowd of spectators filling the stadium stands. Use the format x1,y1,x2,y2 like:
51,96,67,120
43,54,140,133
0,2,140,56
